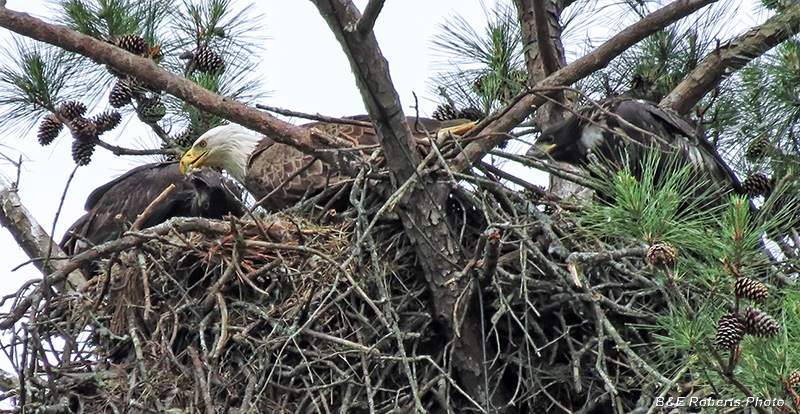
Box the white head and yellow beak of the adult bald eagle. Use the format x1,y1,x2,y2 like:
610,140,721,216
180,124,263,183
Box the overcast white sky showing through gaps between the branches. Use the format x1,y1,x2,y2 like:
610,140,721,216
0,0,759,388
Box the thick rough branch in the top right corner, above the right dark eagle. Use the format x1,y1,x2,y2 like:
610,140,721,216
659,3,800,114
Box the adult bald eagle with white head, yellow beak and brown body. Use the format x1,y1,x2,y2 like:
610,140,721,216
180,116,474,211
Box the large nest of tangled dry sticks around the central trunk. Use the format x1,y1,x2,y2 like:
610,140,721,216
4,183,780,413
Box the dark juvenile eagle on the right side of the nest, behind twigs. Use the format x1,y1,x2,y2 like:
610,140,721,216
528,98,742,199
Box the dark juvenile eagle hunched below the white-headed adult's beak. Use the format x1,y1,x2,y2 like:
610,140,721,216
60,162,244,255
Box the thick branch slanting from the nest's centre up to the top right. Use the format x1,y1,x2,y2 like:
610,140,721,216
453,0,715,171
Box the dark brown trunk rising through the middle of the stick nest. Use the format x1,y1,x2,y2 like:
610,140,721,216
313,0,510,412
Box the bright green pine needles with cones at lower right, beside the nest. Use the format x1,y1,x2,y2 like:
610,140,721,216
576,146,800,408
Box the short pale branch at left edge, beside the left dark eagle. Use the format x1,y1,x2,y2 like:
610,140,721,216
0,170,86,288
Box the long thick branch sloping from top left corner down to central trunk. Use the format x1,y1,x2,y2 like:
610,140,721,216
0,8,358,175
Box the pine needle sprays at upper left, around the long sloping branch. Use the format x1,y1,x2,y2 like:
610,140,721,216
0,0,268,163
